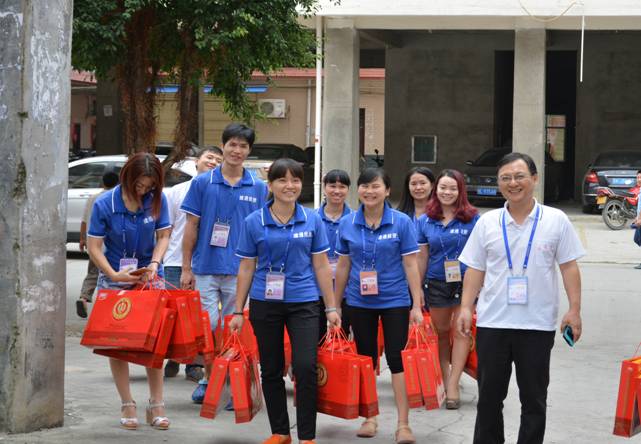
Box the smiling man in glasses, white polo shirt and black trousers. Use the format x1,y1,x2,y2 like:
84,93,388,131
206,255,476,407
457,152,585,444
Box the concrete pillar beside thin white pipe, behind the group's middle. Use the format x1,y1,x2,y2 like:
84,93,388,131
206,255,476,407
321,19,360,208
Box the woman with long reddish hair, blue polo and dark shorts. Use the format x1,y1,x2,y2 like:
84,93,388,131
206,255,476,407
418,170,479,410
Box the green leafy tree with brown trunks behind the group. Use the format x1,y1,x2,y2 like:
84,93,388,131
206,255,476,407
72,0,317,163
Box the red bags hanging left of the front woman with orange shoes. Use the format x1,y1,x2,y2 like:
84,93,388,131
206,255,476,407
200,332,263,424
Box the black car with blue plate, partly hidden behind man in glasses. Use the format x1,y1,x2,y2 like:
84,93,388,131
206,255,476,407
465,147,561,202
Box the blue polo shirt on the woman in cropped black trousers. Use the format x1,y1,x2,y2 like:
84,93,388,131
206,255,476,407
336,204,418,309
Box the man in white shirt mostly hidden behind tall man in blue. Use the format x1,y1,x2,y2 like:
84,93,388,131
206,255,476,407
163,146,223,382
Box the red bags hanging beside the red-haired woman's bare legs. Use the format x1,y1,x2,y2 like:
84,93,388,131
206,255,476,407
401,324,445,410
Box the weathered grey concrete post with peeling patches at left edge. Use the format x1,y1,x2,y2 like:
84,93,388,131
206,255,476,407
0,0,72,433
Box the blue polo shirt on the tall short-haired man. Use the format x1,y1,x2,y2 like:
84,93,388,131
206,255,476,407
180,167,267,275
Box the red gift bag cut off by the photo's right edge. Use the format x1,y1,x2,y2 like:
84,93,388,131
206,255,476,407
612,356,641,437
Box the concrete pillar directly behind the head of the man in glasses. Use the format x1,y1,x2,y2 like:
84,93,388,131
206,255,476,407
512,28,546,202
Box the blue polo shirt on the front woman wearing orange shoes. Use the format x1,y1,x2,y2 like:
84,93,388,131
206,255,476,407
236,200,329,302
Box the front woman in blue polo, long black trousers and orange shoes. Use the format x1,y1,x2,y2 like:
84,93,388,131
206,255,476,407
230,158,340,444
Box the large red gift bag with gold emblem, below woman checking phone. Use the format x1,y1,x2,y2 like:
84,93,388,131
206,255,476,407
80,289,167,352
